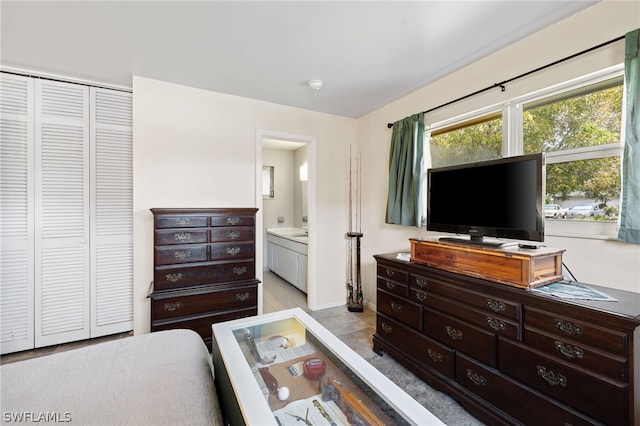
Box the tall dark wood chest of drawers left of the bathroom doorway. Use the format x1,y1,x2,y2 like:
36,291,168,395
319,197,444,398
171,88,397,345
149,208,259,348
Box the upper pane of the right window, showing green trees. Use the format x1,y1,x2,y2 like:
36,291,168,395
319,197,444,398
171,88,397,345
523,85,622,154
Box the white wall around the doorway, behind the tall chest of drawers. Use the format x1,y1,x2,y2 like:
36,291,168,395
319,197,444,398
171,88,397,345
133,76,357,334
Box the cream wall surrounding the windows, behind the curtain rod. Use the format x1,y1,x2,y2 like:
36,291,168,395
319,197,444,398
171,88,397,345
358,1,640,303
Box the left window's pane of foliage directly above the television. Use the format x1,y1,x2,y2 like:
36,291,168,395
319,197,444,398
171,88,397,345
430,118,502,167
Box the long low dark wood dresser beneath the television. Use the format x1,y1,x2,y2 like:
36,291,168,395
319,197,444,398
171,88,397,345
373,253,640,425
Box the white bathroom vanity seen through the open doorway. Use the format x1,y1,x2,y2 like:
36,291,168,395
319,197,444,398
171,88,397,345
267,228,309,293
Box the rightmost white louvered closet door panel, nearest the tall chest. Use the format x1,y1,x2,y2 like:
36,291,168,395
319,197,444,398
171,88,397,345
90,88,133,337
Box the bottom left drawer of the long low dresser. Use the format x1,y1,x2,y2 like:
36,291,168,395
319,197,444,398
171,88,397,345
376,314,454,378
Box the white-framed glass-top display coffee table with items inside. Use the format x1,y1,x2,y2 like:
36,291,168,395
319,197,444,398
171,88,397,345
212,308,444,426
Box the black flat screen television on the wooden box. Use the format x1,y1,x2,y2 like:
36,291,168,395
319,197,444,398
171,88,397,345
427,153,545,247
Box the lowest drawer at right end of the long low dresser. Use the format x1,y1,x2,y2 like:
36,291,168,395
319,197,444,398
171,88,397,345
499,339,629,424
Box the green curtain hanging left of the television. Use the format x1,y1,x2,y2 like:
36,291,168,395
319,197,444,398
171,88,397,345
385,113,424,227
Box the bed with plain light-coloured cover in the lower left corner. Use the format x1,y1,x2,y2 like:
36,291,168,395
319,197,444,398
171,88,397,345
0,330,223,425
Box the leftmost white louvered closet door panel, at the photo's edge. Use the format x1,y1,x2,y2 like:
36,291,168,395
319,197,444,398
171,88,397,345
0,74,34,354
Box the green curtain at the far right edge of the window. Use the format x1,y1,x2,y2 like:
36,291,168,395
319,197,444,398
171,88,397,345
618,29,640,244
